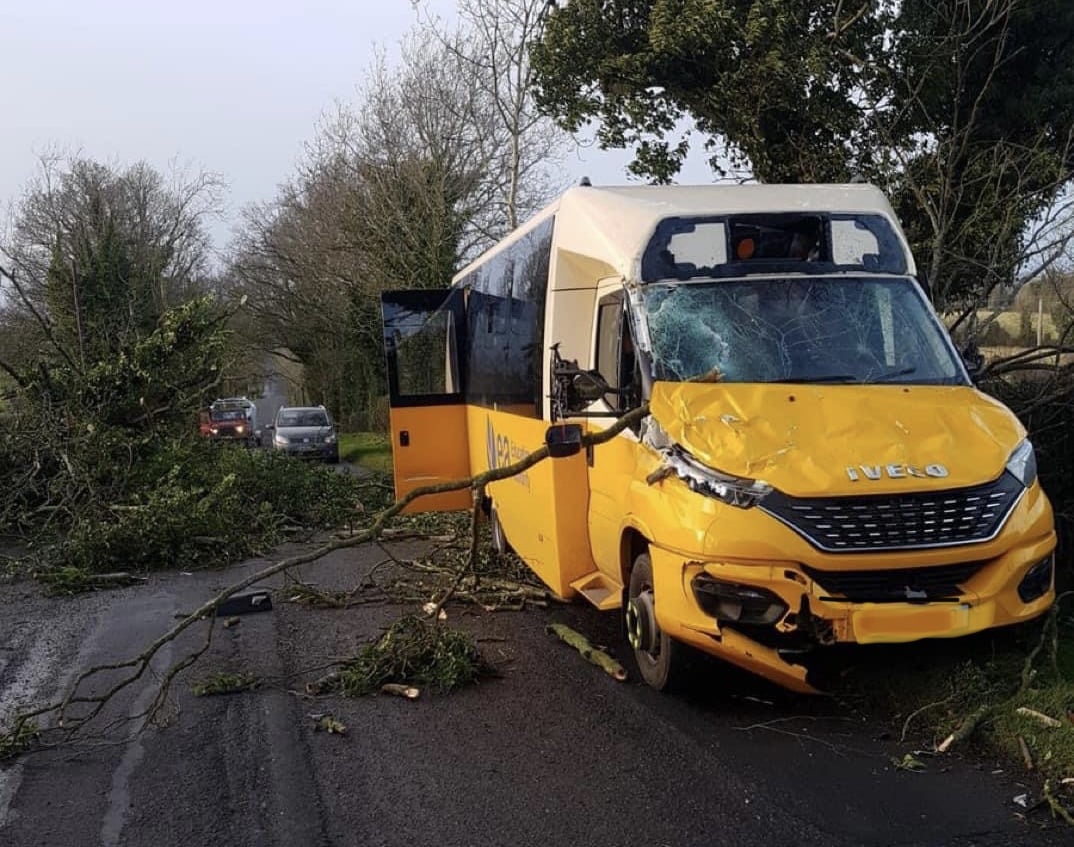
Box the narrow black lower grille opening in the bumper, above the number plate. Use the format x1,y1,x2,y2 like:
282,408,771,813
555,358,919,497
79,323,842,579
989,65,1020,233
802,561,985,603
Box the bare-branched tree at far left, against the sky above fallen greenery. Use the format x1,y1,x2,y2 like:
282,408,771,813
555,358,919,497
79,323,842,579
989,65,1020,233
0,155,222,361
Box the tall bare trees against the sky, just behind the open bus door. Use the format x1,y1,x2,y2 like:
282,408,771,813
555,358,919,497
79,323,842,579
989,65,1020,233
232,18,571,425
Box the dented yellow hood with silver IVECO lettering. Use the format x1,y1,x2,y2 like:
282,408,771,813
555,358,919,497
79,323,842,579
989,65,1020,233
650,382,1025,497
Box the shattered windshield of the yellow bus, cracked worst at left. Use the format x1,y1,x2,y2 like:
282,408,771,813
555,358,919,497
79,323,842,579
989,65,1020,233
642,277,964,384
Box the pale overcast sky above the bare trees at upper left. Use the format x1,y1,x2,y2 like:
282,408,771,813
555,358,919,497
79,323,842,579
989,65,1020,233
0,0,706,247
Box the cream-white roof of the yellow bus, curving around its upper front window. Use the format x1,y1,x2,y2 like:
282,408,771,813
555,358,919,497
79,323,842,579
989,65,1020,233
456,184,915,287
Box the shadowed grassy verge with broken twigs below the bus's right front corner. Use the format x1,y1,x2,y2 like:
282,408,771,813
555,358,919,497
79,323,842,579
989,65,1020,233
840,612,1074,785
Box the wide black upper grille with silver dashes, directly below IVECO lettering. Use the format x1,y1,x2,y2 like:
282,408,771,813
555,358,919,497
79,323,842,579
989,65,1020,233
760,472,1025,553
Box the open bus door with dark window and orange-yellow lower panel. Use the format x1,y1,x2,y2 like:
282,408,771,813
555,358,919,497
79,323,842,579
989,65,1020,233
380,289,471,512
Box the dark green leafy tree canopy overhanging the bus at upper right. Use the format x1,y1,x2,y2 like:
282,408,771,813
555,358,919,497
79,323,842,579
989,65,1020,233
533,0,1074,298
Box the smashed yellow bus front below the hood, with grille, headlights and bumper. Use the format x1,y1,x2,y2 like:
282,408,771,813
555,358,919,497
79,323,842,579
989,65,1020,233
640,399,1055,692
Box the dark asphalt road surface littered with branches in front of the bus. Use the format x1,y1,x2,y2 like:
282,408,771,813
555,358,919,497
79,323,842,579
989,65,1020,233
0,541,1074,847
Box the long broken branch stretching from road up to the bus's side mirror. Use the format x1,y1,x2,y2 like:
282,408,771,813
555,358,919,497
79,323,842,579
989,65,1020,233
0,404,649,741
